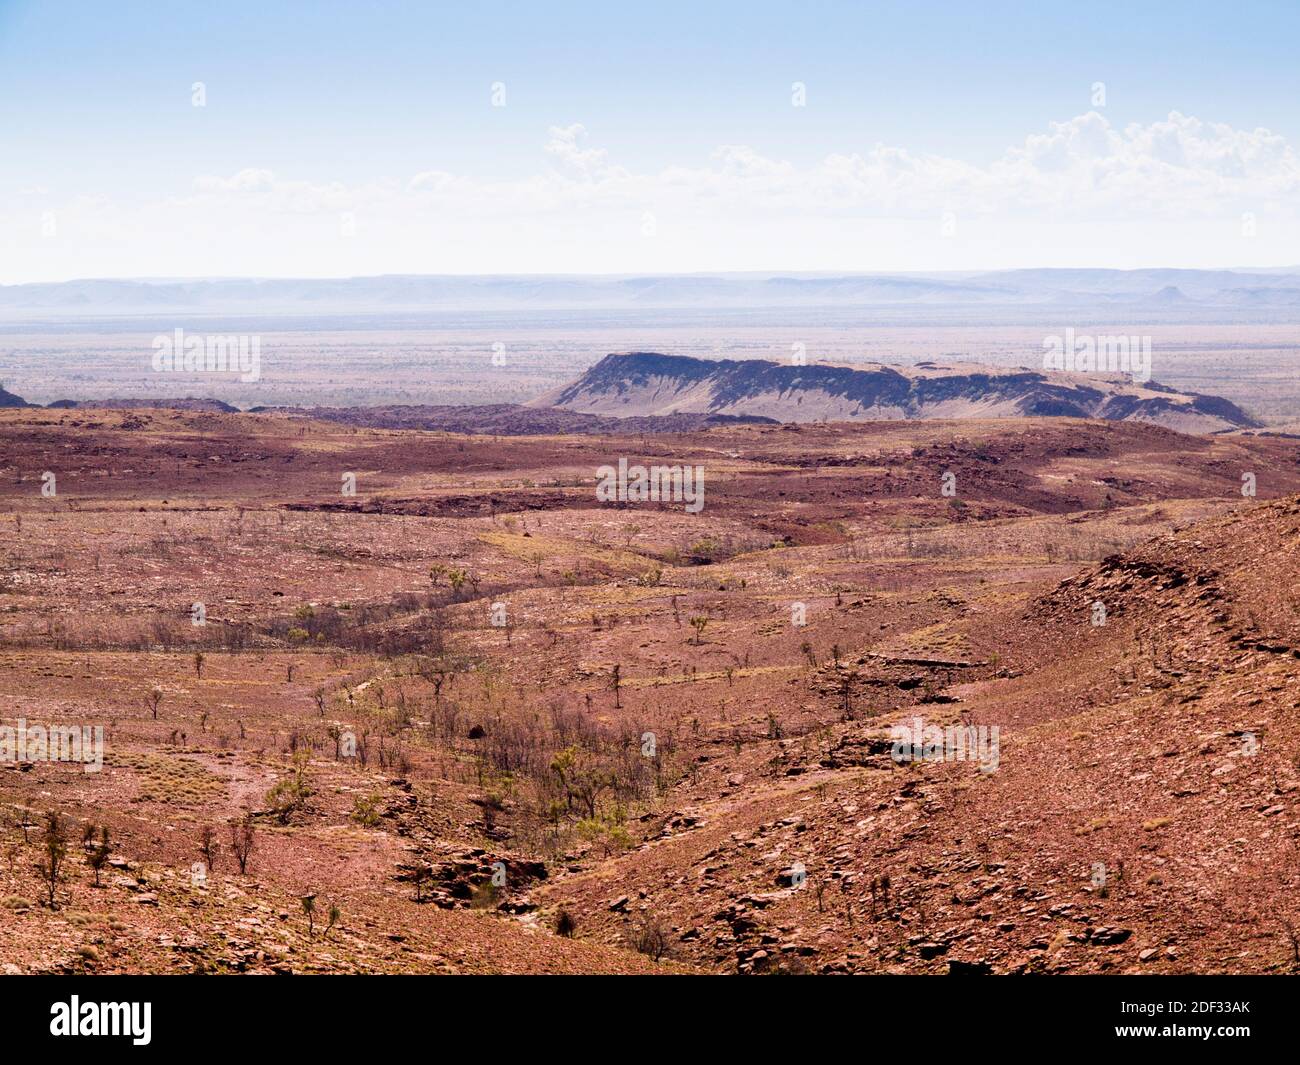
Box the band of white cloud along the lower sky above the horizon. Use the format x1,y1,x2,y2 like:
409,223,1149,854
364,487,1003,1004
0,112,1300,282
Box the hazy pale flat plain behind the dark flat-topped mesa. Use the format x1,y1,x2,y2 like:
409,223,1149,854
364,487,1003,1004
0,315,1300,430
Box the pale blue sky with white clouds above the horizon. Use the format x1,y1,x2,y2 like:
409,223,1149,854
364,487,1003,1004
0,0,1300,283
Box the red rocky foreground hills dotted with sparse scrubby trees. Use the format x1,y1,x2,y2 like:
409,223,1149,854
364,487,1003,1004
0,403,1300,973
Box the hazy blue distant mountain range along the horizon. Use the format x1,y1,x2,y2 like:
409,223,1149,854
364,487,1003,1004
0,267,1300,317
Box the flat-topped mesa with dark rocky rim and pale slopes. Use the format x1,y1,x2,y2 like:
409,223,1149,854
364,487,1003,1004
529,351,1257,433
